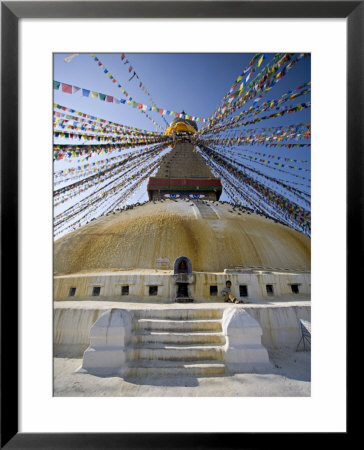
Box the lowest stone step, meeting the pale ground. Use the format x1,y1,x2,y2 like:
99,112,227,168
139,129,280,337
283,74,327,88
124,360,226,377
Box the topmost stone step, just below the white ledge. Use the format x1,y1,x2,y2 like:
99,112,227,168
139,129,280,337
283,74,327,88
133,308,224,320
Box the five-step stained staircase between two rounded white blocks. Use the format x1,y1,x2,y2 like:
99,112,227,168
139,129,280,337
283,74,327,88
125,309,225,377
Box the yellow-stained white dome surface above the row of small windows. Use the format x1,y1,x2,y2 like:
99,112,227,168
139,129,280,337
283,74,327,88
54,200,310,274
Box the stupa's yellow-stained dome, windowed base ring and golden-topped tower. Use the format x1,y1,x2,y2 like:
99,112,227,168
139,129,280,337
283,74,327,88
54,114,310,303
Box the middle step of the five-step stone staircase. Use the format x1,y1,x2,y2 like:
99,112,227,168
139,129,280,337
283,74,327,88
129,331,226,345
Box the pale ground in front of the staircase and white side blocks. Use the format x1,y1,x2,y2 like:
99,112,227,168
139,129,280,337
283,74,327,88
54,349,311,397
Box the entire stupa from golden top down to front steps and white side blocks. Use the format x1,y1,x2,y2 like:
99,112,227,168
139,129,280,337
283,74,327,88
54,116,310,377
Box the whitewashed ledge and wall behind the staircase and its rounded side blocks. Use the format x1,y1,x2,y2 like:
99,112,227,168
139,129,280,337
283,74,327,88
54,300,311,356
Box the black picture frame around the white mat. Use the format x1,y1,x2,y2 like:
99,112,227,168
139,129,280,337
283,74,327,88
1,1,356,449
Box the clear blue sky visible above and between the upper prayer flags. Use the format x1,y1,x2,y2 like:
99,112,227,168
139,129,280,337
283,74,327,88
54,53,310,131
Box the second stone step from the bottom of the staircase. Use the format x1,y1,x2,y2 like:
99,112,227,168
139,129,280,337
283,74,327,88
126,345,223,361
